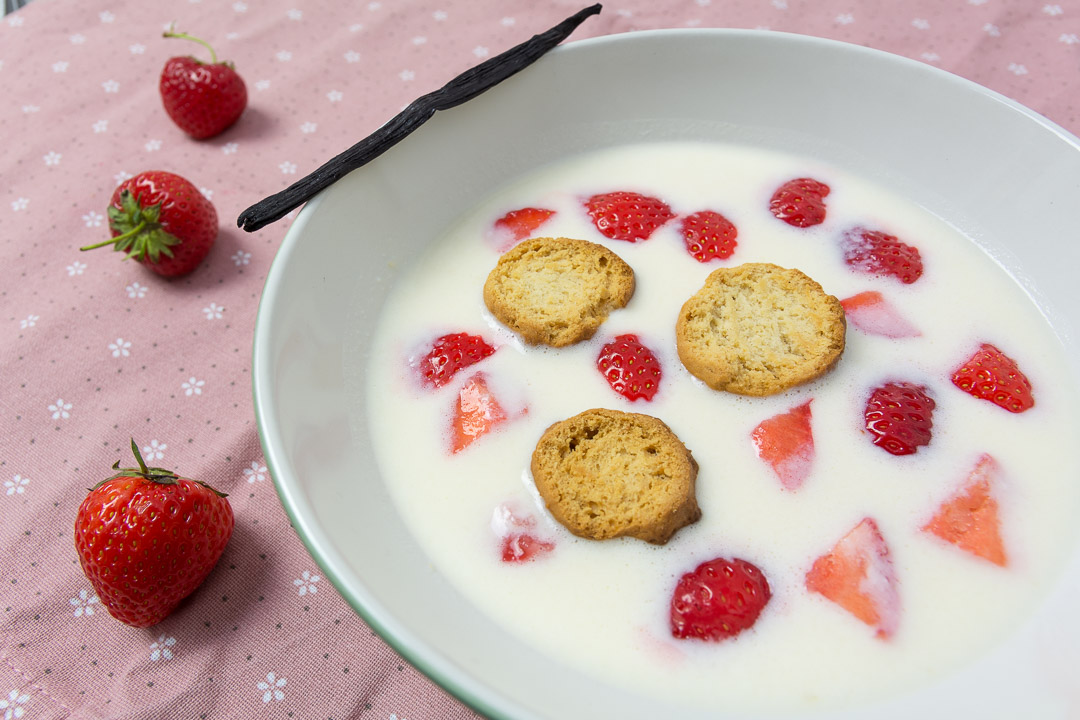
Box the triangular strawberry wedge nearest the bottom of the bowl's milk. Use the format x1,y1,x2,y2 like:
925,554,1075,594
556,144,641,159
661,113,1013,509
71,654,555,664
806,517,900,639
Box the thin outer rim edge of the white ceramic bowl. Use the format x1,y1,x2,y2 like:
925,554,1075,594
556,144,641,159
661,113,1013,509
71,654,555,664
252,28,1080,720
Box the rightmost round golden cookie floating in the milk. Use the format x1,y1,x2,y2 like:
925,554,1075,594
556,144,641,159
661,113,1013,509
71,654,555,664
675,262,847,395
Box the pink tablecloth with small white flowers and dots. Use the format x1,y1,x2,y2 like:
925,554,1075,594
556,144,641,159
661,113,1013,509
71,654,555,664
0,0,1080,720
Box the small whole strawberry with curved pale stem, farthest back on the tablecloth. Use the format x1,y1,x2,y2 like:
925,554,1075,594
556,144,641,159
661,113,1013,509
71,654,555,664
159,30,247,140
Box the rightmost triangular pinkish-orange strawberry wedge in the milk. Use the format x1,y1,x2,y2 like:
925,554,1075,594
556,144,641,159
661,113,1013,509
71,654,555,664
922,453,1007,568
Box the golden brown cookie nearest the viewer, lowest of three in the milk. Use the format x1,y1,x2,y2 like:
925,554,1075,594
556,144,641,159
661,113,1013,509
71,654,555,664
531,409,701,545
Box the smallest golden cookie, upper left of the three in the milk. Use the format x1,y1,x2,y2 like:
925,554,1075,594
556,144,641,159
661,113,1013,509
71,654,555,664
484,237,634,348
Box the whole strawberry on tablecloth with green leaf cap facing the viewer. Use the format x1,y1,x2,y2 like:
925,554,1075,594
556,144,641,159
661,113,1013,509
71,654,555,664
80,171,217,277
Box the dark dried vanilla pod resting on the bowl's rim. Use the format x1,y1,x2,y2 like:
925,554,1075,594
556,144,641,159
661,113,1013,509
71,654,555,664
237,4,600,232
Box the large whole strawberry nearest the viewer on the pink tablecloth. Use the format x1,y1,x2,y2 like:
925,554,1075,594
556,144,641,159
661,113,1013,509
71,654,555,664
75,440,234,627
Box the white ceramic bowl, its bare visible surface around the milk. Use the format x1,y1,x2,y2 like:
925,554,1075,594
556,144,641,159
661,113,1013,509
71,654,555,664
253,30,1080,720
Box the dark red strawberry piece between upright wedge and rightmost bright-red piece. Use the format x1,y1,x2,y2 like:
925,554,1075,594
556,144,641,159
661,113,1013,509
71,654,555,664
863,382,936,456
